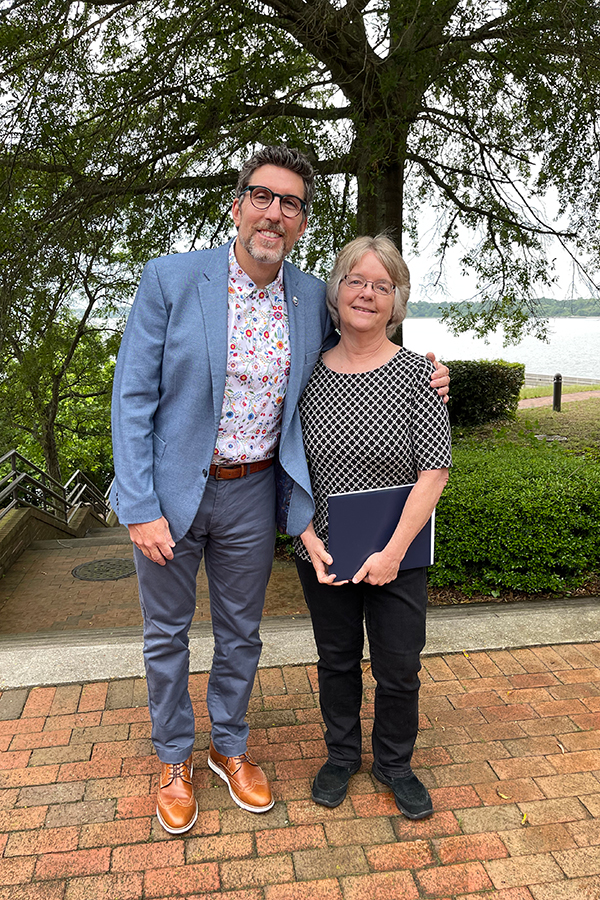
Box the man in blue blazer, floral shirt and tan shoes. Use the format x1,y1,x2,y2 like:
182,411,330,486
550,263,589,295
111,147,447,834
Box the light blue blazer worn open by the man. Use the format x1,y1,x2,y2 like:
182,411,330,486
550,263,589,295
110,244,333,541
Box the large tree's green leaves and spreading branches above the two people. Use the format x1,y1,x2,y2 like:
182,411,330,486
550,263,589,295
0,0,600,474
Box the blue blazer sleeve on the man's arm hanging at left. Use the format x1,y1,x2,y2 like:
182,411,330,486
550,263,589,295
111,260,169,525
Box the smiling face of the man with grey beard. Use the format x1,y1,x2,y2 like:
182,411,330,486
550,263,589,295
231,165,306,287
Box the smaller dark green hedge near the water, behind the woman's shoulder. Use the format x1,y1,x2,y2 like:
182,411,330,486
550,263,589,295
445,359,525,425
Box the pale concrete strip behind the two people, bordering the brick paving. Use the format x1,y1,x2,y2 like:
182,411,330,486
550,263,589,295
0,597,600,690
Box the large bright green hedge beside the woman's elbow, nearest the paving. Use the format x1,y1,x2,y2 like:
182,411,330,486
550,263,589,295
429,446,600,593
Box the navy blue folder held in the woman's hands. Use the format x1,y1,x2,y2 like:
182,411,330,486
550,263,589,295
327,484,435,581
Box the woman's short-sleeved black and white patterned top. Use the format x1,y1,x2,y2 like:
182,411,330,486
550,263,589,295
294,347,452,561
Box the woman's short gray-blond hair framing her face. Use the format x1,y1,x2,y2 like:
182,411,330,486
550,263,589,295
327,234,410,337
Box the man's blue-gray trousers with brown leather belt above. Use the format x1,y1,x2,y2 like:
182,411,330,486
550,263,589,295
134,466,275,763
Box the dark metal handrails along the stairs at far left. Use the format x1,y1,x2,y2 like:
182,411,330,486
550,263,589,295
0,450,111,523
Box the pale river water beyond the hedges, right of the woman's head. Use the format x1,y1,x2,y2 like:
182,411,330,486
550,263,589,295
403,316,600,381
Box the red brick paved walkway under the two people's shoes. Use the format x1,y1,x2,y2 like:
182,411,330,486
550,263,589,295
0,644,600,900
